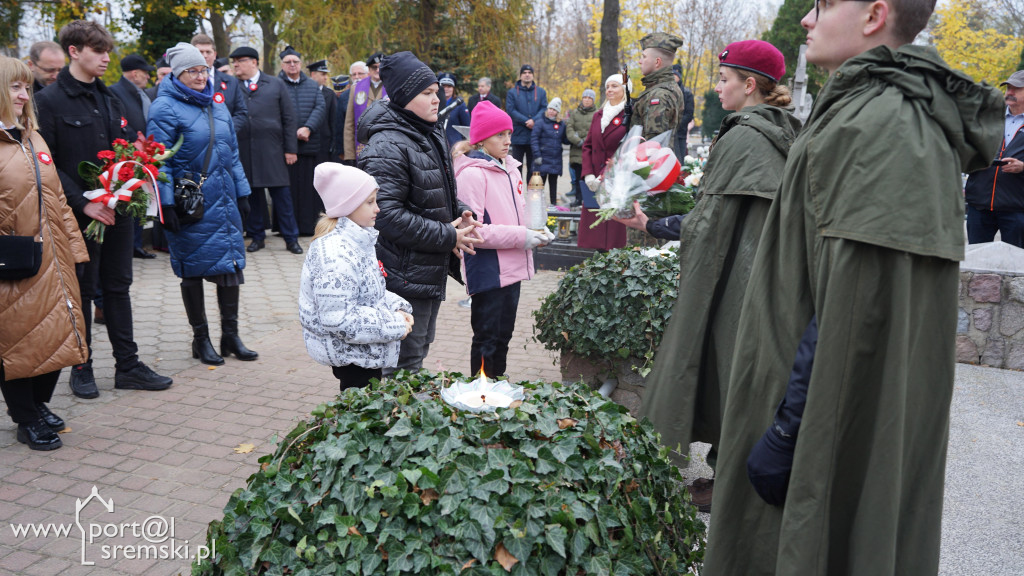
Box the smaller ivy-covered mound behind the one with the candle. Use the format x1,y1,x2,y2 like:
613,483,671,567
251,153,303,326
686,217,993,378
534,248,679,376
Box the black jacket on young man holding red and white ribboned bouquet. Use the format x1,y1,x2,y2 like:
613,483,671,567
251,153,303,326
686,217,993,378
36,67,129,228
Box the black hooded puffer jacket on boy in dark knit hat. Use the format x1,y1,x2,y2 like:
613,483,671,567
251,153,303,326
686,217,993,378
356,99,469,300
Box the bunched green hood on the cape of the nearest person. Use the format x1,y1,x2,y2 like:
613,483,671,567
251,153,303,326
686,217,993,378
807,45,1005,172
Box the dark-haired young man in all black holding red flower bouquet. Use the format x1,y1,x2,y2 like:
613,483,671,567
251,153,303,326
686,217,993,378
36,20,172,398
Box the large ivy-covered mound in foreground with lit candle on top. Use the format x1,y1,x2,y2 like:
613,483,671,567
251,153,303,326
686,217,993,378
193,372,706,576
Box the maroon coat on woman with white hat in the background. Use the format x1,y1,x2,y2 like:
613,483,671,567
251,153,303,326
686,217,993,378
577,107,627,250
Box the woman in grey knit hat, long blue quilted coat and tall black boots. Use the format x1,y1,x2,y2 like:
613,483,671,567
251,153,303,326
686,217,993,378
147,42,259,366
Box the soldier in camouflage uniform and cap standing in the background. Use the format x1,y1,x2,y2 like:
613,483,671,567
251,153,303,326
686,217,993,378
632,32,683,141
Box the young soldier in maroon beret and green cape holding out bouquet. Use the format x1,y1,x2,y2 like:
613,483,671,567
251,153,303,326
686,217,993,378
620,40,800,511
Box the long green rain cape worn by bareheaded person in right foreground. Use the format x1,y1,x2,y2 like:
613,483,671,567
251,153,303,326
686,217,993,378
702,45,1004,576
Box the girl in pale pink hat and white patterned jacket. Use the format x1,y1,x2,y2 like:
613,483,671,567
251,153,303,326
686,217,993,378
299,162,413,392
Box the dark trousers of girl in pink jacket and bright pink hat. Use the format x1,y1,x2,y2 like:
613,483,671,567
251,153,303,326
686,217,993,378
469,282,522,376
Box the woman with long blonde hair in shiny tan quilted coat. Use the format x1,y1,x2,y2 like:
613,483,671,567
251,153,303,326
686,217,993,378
0,56,89,450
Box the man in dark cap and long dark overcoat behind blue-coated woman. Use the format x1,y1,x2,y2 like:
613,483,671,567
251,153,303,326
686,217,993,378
229,46,302,254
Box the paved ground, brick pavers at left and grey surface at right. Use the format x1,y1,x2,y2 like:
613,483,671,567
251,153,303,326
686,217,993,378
0,237,1024,576
